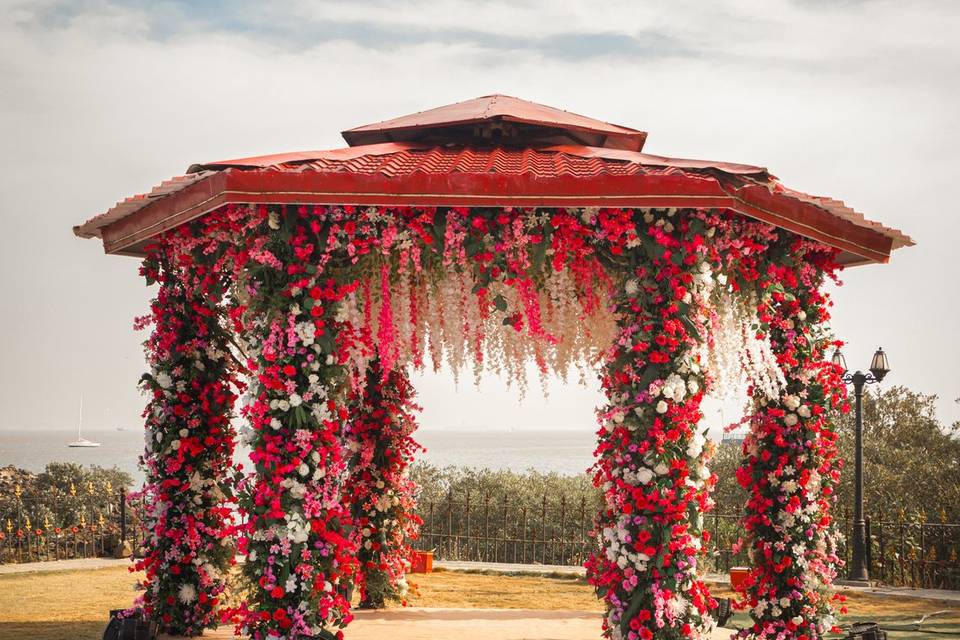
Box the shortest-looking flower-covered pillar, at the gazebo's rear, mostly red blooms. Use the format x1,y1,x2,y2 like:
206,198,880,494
345,360,422,608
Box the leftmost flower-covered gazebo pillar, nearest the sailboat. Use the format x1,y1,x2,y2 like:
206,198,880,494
135,245,237,635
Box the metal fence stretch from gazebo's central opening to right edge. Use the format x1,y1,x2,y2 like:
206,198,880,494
414,493,960,589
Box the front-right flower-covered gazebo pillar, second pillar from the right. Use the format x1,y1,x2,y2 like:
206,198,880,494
587,210,715,640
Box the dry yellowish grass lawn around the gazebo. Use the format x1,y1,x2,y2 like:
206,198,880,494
0,568,960,640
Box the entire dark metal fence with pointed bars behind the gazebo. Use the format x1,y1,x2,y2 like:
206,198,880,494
0,486,960,589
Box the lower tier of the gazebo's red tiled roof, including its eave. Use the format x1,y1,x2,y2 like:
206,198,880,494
74,93,913,263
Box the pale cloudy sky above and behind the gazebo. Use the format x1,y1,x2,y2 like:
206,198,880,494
0,0,960,440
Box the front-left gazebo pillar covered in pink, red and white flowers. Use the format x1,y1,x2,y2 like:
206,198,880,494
237,207,354,640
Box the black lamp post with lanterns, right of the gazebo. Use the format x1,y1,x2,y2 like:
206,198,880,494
832,348,890,582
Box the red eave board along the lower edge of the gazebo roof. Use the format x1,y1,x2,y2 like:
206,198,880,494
80,169,912,265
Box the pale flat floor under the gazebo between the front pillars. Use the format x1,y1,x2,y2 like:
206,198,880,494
180,607,733,640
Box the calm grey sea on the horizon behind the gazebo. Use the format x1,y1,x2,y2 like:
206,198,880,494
0,428,596,483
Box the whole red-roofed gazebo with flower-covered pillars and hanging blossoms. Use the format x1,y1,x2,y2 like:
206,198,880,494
74,95,912,640
